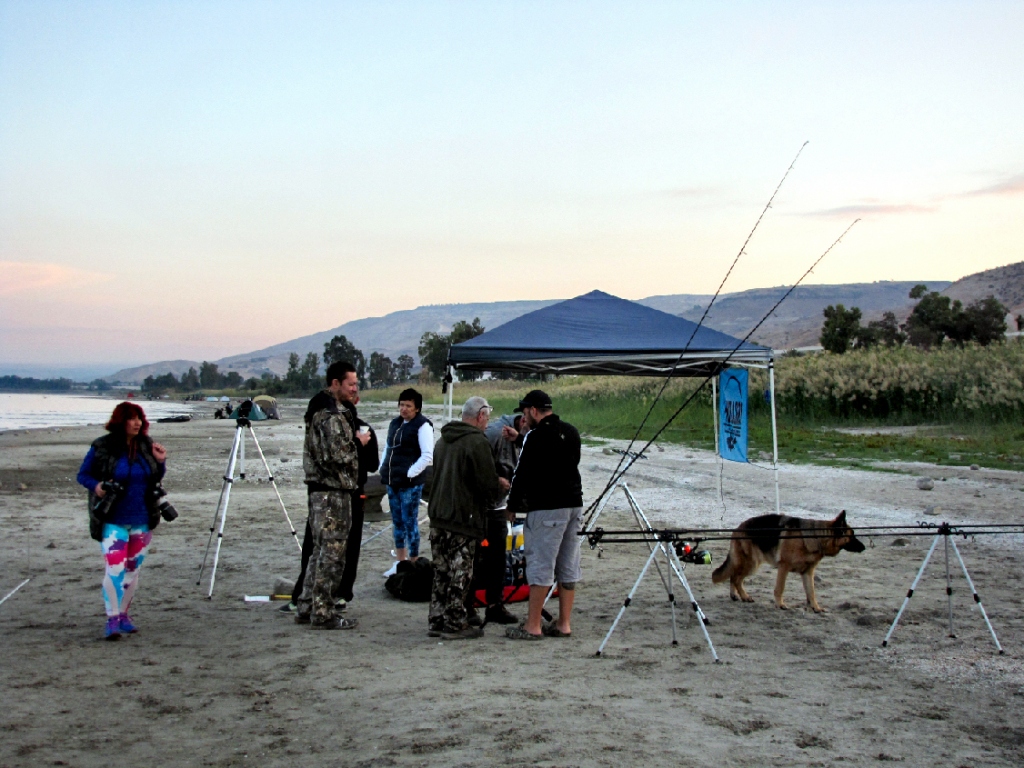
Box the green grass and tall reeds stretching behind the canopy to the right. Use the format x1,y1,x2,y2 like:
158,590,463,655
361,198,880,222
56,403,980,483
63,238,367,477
362,341,1024,470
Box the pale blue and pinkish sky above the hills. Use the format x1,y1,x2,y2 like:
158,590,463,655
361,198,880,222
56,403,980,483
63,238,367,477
0,0,1024,374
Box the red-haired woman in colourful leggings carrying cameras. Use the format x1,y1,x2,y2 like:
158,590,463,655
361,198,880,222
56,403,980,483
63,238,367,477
78,402,167,640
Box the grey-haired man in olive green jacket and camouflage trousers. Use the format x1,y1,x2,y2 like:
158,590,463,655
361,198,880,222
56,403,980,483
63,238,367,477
427,397,509,640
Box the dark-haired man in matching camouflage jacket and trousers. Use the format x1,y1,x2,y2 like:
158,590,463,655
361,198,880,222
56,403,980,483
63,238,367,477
295,360,370,630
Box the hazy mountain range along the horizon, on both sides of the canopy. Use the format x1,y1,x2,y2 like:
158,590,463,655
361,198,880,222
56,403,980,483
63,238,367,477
103,261,1024,384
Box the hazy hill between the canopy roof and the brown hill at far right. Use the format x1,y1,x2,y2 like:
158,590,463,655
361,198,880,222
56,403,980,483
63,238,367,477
680,281,950,349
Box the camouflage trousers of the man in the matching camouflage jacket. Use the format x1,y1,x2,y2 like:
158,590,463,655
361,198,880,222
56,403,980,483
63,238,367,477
296,490,352,624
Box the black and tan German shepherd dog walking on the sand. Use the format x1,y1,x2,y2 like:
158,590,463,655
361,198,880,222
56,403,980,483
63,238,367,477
711,510,864,613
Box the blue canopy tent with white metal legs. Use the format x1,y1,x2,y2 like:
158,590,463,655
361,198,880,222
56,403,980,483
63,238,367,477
445,291,779,508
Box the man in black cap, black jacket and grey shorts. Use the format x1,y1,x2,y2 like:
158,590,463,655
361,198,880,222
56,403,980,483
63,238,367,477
505,389,583,640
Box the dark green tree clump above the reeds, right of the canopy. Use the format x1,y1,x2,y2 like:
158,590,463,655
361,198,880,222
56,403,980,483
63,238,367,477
819,285,1011,354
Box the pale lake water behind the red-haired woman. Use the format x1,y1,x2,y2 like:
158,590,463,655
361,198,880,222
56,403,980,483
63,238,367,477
0,392,191,431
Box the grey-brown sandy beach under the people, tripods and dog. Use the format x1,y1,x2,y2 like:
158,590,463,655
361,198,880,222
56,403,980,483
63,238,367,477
0,399,1024,766
